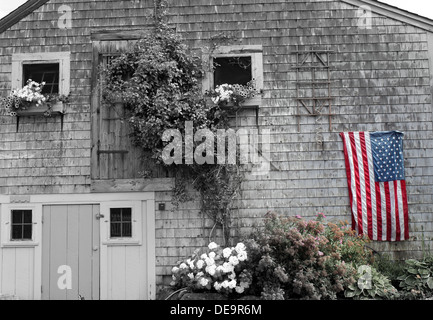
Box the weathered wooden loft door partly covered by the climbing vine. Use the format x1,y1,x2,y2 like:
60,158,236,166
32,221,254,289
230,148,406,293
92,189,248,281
92,40,141,180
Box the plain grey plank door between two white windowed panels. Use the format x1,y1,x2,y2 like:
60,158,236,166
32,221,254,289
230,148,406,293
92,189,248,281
42,205,100,300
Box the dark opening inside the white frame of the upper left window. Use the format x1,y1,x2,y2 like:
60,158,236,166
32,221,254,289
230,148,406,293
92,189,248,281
23,63,60,94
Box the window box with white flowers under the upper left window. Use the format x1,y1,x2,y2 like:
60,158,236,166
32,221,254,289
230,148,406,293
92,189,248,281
1,79,68,117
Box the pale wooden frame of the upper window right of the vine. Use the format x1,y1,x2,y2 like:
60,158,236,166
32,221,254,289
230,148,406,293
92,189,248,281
203,45,264,106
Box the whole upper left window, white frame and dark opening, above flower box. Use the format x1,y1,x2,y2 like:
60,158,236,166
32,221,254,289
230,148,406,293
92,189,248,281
12,52,71,95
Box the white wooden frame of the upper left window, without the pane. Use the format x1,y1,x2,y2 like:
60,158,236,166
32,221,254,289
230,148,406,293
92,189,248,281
12,51,71,96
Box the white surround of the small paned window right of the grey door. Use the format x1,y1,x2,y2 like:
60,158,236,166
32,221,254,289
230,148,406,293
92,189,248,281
100,201,143,246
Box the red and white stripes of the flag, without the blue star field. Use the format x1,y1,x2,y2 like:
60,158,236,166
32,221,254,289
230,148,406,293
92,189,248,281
340,132,409,241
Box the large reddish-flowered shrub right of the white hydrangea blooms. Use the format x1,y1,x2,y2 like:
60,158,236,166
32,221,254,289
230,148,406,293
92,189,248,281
245,213,368,299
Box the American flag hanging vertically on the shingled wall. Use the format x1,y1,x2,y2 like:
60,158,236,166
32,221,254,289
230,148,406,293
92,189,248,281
340,131,409,241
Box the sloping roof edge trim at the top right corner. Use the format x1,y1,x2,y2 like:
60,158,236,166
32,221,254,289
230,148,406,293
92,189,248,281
340,0,433,32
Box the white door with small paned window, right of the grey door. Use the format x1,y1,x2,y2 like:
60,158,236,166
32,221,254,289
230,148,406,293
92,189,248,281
100,201,154,300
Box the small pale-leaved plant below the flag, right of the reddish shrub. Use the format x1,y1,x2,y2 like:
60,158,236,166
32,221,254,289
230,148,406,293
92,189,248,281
344,265,399,300
